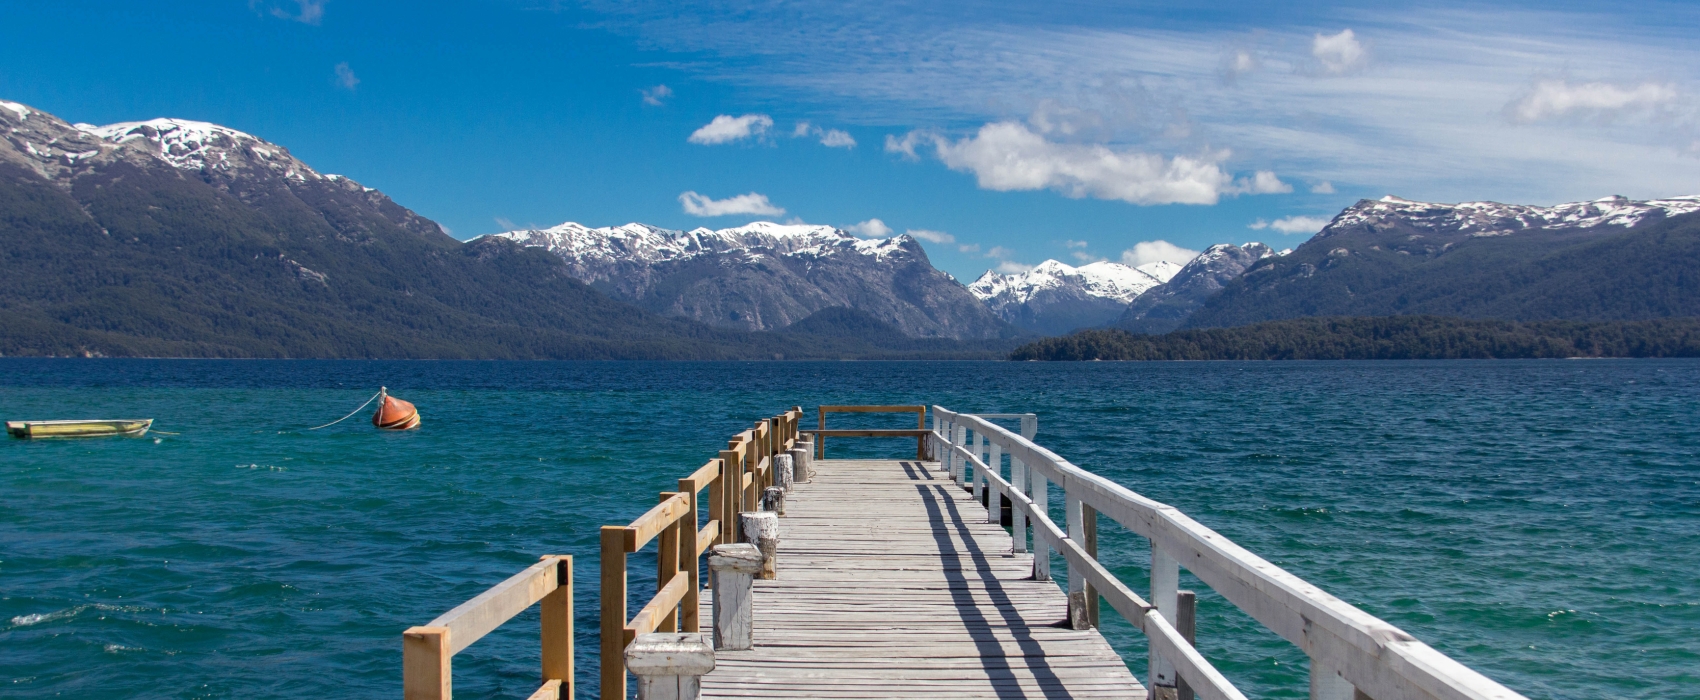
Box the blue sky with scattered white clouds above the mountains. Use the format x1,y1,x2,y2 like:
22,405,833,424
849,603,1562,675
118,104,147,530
0,0,1700,279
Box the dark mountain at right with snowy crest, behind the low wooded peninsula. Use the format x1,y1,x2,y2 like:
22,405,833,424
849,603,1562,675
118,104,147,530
1187,195,1700,328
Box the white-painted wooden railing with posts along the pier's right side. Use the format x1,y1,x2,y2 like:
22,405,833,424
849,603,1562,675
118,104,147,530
930,406,1522,700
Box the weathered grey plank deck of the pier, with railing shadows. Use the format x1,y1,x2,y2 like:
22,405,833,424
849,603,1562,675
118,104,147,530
702,460,1146,698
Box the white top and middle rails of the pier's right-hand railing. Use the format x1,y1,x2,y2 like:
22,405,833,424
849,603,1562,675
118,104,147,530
932,406,1522,700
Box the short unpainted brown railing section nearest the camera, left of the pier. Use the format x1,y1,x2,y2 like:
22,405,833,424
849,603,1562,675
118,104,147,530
401,554,573,700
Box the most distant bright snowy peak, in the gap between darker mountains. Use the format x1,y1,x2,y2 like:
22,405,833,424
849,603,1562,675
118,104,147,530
967,260,1182,335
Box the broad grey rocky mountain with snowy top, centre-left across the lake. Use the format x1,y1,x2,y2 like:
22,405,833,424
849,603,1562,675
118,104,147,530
495,221,1013,338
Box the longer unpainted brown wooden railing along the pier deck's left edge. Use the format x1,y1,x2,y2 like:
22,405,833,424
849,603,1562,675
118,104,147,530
602,406,802,700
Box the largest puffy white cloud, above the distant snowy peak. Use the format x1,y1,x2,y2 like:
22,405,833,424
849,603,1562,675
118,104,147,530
886,122,1285,204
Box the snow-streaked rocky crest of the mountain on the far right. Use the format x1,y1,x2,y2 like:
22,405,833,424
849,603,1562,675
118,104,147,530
1316,195,1700,238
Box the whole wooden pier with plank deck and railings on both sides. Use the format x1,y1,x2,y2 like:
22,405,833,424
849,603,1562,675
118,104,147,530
403,406,1522,700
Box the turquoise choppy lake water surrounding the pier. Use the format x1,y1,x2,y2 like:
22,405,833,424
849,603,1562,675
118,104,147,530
0,358,1700,700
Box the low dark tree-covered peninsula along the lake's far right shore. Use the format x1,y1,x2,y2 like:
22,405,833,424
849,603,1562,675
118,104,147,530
1010,316,1700,360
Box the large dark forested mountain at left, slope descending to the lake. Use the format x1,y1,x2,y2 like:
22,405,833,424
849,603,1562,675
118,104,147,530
0,102,1010,358
